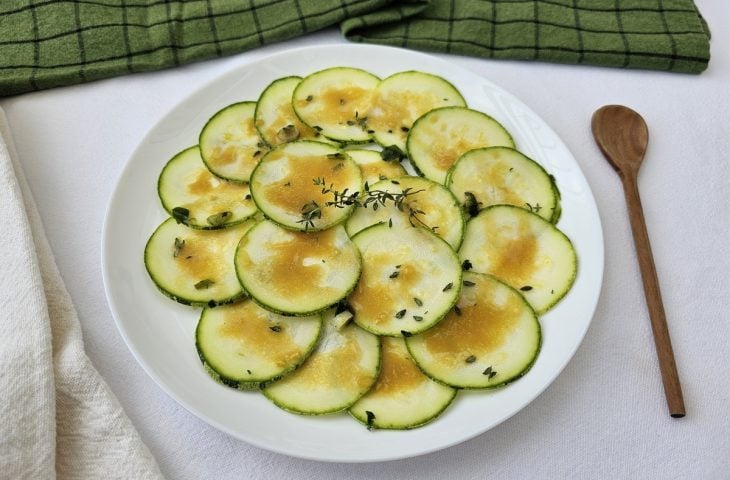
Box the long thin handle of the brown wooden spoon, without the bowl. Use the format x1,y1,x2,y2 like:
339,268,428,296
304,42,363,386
622,172,685,418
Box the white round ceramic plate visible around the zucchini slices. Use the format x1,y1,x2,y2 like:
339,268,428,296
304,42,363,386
102,45,603,462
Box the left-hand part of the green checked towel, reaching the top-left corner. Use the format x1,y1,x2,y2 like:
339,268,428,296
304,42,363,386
0,0,428,97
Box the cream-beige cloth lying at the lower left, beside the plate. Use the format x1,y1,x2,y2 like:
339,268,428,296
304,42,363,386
0,109,163,479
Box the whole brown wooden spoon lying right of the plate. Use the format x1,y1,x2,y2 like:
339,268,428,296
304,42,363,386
591,105,685,418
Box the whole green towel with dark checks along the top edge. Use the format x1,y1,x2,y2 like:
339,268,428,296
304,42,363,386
0,0,709,96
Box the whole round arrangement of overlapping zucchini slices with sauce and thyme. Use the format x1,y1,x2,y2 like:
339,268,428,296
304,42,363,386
144,66,578,430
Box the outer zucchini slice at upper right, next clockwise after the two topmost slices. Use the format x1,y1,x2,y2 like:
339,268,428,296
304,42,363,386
406,107,515,183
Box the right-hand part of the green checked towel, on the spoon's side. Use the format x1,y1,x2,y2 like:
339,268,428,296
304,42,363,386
342,0,710,73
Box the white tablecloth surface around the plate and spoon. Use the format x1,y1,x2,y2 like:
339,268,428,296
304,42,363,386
0,0,730,479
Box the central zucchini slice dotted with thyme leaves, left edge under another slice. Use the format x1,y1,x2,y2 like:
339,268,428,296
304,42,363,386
348,223,462,336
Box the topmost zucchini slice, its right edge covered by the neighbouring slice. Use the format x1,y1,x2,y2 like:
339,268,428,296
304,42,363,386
292,67,380,143
